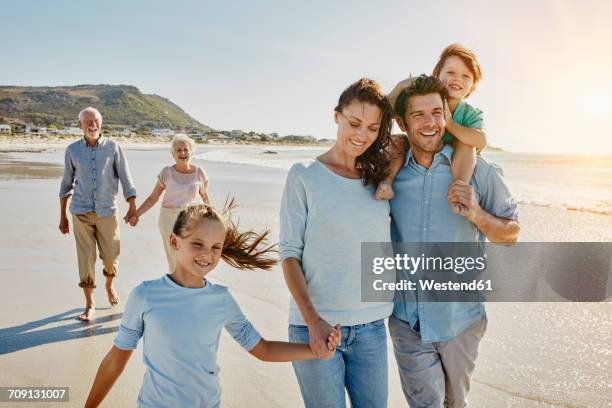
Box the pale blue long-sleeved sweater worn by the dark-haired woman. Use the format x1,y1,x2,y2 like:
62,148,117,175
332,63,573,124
279,160,393,326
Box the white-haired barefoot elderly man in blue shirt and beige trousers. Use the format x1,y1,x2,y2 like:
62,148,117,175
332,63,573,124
59,107,136,321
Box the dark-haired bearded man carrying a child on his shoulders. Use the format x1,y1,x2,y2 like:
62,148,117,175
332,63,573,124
389,75,520,407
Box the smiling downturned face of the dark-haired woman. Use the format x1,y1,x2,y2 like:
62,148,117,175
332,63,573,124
334,100,381,157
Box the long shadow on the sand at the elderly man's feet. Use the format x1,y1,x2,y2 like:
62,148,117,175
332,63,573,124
0,308,123,355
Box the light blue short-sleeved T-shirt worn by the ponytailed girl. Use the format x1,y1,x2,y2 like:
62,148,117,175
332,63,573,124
114,275,261,408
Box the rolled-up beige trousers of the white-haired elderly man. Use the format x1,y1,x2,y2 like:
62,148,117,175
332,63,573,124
72,211,119,288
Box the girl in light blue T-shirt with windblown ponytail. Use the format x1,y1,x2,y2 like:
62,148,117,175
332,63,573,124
85,203,339,407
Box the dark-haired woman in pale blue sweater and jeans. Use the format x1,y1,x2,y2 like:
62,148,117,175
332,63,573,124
279,78,393,408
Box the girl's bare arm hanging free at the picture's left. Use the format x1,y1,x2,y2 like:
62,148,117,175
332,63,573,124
85,346,133,408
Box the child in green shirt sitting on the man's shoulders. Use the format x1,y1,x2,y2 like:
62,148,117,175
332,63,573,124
375,44,487,212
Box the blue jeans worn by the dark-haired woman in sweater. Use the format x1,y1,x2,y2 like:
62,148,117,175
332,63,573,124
289,319,389,408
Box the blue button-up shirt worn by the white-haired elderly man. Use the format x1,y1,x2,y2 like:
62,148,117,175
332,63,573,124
59,136,136,217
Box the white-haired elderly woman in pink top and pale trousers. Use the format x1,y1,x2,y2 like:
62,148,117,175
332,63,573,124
130,135,209,273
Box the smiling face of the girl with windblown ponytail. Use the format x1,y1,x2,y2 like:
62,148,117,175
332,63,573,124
170,218,225,286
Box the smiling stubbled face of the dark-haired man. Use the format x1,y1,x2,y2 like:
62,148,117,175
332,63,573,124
399,93,446,157
